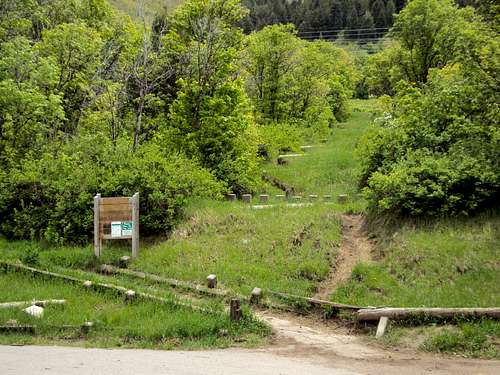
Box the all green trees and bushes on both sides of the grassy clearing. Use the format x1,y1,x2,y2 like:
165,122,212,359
0,0,500,243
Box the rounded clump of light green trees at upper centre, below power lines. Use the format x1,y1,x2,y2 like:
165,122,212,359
242,25,358,127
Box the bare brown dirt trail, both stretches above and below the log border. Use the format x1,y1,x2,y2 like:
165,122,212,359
257,215,500,375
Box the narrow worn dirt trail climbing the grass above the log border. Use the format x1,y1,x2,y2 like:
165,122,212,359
315,215,373,299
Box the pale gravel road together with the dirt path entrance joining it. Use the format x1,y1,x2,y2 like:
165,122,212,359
0,311,500,375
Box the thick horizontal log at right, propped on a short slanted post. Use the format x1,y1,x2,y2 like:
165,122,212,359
356,307,500,321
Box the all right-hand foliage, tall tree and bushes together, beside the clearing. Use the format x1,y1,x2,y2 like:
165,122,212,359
361,0,500,216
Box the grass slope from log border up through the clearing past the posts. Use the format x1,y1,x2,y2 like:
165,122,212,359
129,105,374,296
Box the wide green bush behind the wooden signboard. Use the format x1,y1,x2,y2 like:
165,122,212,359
0,138,222,244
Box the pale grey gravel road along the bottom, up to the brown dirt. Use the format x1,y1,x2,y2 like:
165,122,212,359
0,346,360,375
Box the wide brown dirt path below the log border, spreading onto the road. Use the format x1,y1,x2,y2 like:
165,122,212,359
257,311,500,375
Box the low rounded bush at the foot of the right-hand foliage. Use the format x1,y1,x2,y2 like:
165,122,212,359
367,150,500,216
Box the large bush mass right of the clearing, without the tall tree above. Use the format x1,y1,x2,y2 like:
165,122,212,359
361,65,500,216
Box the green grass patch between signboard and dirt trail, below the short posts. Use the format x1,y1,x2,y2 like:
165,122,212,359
132,202,340,295
